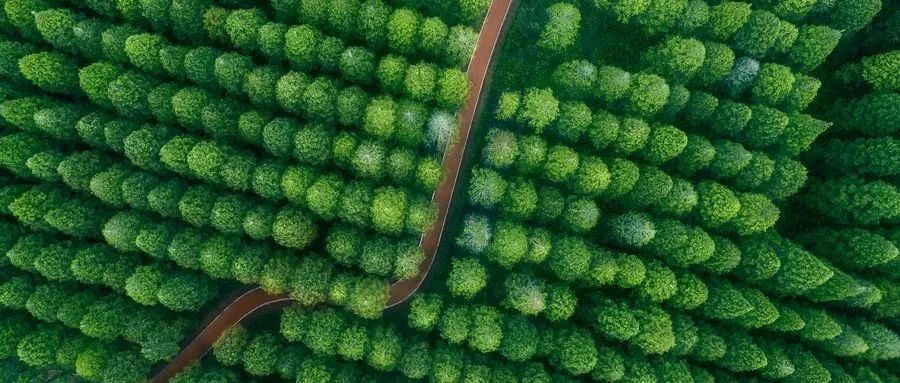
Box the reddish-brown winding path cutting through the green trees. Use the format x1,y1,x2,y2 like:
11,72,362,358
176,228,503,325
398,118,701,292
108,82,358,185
150,0,515,383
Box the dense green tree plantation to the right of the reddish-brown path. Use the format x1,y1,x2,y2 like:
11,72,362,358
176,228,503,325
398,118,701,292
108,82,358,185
412,0,900,382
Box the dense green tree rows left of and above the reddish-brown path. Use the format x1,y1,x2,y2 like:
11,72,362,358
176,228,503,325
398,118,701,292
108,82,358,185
0,0,487,383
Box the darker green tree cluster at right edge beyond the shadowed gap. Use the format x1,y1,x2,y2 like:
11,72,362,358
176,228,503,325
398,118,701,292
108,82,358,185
788,21,900,323
